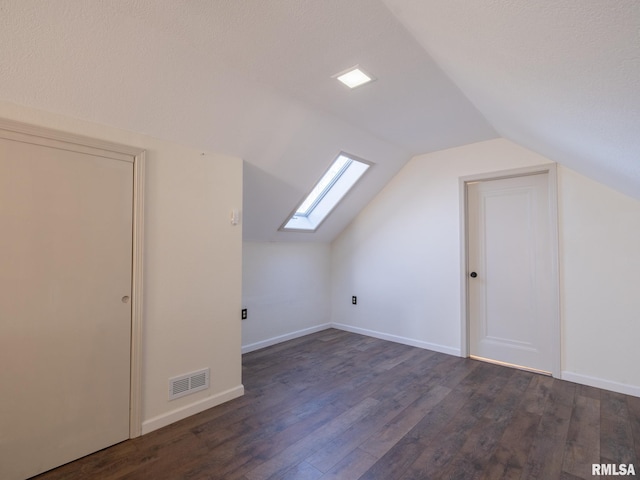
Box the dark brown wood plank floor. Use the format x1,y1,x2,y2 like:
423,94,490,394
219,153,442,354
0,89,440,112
36,330,640,480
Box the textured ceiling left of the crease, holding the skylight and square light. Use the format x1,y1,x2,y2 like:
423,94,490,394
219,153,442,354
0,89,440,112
0,0,497,241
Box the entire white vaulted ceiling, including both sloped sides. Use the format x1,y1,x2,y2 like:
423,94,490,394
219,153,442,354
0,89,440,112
0,0,640,241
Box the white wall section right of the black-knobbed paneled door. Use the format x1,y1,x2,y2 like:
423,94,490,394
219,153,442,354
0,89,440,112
559,168,640,396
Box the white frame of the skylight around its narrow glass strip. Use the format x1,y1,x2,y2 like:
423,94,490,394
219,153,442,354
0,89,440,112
279,152,373,233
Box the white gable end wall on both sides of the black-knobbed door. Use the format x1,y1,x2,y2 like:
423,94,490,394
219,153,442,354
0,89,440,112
331,139,640,395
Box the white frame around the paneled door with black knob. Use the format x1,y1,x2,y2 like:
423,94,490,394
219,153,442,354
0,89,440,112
459,163,562,378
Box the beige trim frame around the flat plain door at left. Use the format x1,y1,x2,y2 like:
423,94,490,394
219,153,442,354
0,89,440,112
0,118,146,438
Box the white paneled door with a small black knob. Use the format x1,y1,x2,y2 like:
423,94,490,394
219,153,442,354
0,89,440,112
467,173,558,373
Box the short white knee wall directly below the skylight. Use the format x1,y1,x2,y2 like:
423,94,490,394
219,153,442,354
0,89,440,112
242,242,331,352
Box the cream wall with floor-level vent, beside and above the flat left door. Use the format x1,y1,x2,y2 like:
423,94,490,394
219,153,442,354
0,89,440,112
0,102,243,432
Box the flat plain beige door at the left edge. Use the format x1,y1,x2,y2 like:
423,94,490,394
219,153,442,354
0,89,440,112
0,132,133,480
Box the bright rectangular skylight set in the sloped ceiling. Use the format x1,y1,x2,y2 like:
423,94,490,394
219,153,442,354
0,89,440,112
280,153,371,231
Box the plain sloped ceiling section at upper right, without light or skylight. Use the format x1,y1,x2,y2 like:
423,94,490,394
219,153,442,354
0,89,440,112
384,0,640,198
